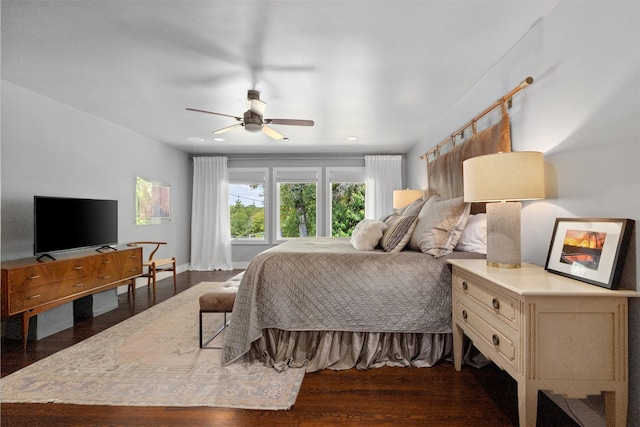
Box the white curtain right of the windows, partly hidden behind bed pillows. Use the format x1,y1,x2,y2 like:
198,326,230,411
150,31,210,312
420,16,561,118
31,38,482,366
364,155,402,219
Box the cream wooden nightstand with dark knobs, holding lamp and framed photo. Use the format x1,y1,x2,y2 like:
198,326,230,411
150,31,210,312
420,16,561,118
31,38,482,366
448,259,640,427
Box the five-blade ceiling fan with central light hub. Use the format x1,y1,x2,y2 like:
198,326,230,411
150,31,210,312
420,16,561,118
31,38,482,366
187,89,314,139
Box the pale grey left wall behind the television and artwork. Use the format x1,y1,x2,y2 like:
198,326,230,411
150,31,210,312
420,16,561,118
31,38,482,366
0,80,192,265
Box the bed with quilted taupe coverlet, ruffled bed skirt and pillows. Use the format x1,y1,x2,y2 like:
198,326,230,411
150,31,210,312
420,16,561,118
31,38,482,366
222,113,510,372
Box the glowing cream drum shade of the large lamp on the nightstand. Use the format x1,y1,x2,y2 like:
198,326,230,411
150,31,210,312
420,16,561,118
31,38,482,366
462,151,544,202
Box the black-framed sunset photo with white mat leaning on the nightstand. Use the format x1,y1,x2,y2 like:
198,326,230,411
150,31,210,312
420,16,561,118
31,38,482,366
544,218,635,289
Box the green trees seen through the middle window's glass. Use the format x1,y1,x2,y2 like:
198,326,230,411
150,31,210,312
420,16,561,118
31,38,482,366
279,182,316,238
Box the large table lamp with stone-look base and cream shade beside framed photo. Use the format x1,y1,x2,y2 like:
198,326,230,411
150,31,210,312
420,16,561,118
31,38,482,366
462,151,544,268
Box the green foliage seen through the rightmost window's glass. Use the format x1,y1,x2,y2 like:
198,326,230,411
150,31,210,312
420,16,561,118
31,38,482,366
331,183,365,237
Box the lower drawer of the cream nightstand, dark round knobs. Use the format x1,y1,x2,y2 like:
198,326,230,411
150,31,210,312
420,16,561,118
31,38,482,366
454,299,519,368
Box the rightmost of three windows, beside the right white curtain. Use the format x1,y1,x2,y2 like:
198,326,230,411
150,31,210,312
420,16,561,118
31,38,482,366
326,168,365,237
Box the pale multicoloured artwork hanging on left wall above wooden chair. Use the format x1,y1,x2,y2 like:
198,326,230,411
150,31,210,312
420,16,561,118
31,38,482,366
136,176,171,225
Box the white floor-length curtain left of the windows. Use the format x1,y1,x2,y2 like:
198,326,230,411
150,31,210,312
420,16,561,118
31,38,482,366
189,157,233,270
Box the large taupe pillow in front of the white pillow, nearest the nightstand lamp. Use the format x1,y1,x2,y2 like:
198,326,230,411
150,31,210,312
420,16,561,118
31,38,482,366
409,196,471,258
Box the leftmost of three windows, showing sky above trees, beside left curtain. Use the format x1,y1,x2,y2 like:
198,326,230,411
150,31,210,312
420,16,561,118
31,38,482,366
228,168,268,243
